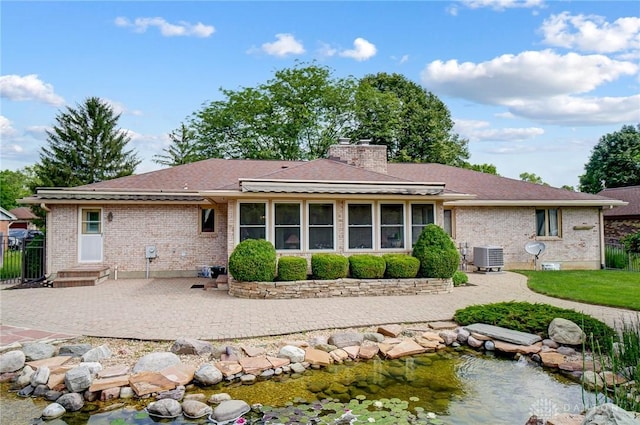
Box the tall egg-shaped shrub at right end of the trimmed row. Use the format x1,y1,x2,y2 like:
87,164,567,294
413,224,460,279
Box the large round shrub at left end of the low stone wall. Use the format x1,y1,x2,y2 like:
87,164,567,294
229,239,276,282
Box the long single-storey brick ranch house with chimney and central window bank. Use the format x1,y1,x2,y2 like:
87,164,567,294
24,141,625,277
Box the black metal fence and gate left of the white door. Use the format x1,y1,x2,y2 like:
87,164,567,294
0,235,46,285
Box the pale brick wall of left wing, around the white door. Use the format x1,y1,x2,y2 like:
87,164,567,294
47,204,227,277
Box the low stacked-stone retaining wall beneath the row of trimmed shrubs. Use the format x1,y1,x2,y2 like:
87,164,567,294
229,278,453,299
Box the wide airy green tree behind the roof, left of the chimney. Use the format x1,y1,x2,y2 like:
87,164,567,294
192,64,355,160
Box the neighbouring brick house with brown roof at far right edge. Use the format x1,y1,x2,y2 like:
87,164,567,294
598,186,640,242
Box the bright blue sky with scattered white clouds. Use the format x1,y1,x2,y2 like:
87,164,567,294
0,0,640,186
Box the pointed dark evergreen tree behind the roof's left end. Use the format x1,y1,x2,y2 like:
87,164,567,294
35,97,140,187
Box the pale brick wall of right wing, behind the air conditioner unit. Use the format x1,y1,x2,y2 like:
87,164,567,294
455,207,600,269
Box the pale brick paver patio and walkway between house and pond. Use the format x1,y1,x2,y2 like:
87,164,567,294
0,272,638,345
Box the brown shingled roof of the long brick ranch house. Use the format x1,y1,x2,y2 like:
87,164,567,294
24,159,624,207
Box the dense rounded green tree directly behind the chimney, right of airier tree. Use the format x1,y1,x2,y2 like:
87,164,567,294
349,72,469,166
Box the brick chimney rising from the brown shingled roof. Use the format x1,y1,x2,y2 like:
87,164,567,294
329,138,387,174
